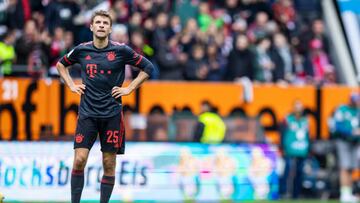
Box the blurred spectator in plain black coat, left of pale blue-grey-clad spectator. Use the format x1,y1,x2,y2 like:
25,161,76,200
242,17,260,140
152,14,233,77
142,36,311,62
225,35,255,81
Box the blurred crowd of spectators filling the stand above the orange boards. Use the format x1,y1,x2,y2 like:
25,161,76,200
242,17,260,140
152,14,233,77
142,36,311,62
0,0,336,84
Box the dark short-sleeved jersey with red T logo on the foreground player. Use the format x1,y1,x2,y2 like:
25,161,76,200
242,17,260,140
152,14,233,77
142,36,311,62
60,41,154,118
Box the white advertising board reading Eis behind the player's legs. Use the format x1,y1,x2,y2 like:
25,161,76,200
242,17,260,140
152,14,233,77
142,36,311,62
0,142,278,201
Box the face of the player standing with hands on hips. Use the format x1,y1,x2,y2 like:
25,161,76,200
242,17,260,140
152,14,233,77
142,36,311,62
90,16,111,39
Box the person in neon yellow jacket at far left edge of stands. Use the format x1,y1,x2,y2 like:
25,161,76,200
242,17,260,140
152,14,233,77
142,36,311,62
0,30,16,76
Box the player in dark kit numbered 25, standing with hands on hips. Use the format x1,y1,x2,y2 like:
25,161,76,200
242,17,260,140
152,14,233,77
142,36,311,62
56,10,154,203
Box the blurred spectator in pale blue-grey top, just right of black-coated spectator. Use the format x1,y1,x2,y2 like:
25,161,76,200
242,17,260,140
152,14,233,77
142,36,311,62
254,37,275,83
